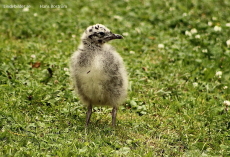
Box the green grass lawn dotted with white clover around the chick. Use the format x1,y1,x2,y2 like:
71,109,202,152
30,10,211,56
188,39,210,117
0,0,230,157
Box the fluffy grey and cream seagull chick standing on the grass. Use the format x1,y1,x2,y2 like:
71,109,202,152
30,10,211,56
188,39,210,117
70,24,128,126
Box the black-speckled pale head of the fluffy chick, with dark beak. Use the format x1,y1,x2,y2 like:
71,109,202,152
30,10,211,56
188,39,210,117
81,24,123,44
